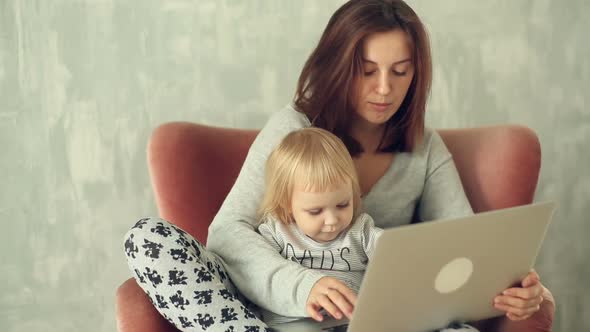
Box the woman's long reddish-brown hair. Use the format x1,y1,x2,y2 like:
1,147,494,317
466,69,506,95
294,0,432,156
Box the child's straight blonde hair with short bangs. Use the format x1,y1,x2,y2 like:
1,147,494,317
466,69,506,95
258,128,361,223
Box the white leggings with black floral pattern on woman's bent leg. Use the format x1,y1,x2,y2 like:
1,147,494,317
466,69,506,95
125,218,270,332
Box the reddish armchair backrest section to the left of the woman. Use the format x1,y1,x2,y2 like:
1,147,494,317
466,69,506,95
148,122,258,243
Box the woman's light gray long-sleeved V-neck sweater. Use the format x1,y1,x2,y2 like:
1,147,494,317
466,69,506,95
207,106,473,317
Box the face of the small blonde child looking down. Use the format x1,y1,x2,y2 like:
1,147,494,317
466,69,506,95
291,181,353,242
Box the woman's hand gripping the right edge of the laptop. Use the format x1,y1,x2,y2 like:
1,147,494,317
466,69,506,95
494,270,543,321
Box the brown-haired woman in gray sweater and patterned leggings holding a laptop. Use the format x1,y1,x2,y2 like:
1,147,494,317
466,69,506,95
126,0,546,330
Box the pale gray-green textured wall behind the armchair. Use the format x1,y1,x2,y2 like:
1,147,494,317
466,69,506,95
0,0,590,332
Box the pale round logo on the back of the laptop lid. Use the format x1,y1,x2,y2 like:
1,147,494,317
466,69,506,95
434,257,473,294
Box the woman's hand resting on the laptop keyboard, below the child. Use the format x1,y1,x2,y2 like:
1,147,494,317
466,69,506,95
306,277,356,322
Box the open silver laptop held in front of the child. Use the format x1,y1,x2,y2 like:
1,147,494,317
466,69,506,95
271,202,555,332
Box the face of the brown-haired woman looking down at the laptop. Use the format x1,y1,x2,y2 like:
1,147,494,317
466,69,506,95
353,29,414,128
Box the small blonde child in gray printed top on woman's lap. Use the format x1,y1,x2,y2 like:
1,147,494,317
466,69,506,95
258,128,477,331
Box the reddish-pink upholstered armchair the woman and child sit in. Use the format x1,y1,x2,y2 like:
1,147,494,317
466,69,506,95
116,122,555,332
